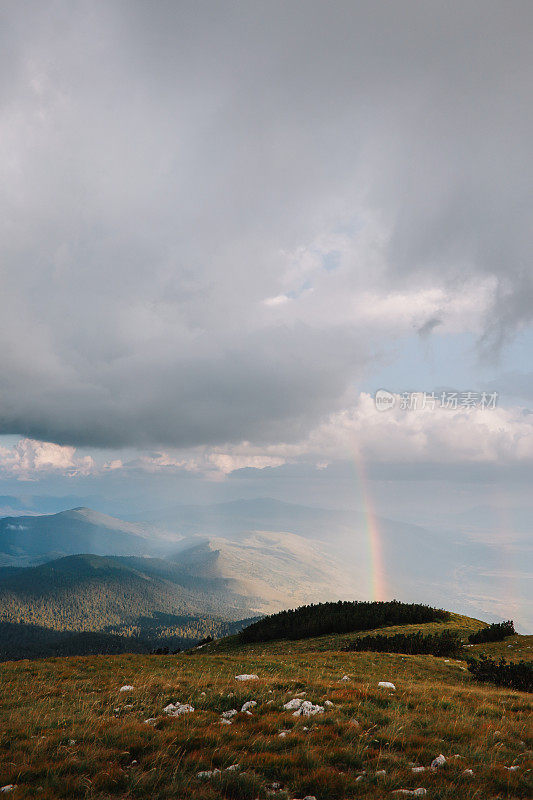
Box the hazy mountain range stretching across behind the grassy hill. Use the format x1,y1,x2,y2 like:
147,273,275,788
0,498,530,656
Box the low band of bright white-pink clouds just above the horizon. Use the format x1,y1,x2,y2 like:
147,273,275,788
0,393,533,480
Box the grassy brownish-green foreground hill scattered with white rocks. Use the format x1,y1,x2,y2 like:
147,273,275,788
0,615,533,800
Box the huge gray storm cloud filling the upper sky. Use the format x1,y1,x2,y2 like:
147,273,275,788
0,0,533,446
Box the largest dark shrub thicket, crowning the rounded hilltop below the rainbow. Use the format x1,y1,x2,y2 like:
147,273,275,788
239,600,450,642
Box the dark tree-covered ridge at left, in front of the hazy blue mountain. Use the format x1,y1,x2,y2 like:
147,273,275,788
0,555,260,660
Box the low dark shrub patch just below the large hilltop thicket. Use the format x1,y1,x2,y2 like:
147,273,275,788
343,631,462,656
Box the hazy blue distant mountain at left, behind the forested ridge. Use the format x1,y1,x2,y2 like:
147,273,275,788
0,508,179,566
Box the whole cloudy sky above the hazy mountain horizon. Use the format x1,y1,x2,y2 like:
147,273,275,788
0,0,533,568
